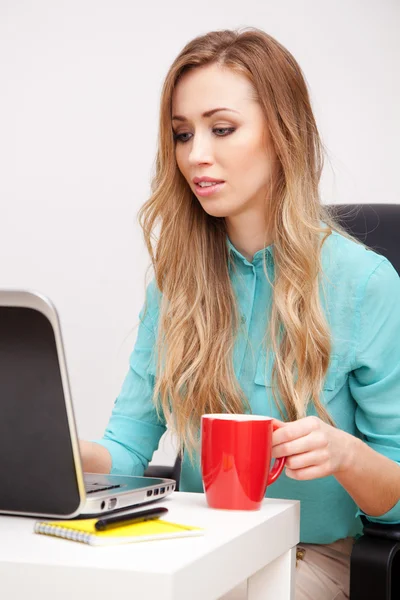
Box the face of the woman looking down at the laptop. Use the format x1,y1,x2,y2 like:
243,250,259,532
172,65,275,220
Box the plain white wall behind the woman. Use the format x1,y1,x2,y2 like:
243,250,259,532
0,0,400,459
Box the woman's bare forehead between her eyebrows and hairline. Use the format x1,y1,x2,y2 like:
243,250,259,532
172,65,254,118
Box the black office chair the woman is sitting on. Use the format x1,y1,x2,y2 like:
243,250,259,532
145,204,400,600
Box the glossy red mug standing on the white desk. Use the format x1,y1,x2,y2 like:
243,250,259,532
201,413,286,510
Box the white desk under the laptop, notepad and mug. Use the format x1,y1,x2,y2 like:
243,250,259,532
0,492,300,600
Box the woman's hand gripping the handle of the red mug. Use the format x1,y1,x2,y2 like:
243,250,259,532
272,417,357,481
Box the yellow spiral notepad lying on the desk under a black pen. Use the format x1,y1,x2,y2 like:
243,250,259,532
34,519,204,546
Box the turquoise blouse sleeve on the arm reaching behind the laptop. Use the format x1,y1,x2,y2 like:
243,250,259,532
93,281,166,475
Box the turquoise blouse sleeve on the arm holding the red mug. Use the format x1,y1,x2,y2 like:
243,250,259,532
349,259,400,523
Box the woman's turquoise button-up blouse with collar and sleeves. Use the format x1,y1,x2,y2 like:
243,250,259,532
95,232,400,544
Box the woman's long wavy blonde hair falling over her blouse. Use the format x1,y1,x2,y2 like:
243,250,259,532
139,28,337,453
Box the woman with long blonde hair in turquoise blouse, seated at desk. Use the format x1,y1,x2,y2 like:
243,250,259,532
82,29,400,600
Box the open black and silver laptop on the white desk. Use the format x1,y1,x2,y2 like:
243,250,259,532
0,290,175,519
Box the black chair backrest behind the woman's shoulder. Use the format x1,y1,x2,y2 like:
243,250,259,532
329,204,400,274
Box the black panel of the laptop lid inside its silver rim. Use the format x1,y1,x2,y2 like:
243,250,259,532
0,306,80,515
